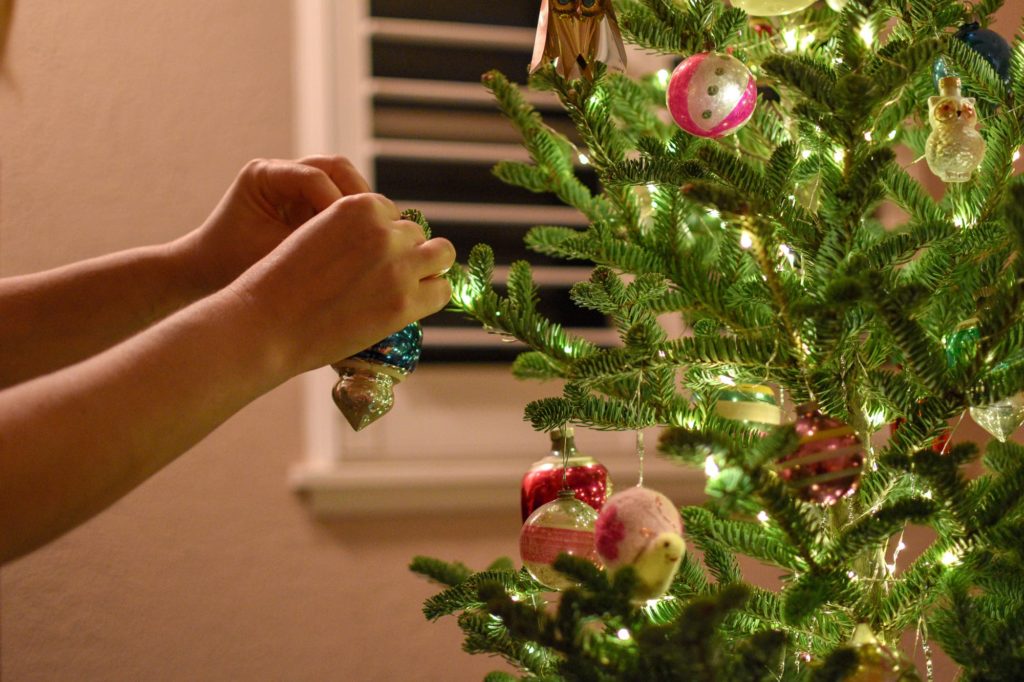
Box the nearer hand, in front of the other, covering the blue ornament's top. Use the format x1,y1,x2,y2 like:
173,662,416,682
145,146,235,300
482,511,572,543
228,188,455,376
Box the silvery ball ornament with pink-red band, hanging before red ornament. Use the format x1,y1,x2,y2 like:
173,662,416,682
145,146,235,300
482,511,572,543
519,489,600,591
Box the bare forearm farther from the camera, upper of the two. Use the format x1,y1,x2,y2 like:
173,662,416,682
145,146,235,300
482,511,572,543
0,235,206,387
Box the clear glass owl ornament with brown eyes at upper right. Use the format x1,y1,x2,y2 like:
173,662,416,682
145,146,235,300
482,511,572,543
925,77,985,182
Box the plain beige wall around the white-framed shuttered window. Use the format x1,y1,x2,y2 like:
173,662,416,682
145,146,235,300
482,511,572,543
0,0,1022,682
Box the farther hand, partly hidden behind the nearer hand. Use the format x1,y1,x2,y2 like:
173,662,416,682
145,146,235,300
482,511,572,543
175,156,370,293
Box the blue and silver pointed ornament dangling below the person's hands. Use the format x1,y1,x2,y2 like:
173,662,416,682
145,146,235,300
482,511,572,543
331,323,423,431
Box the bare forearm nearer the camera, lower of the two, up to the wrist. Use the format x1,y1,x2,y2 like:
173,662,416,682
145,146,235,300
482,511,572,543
0,284,293,561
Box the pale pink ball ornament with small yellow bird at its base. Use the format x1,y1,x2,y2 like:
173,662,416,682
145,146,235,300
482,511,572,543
594,485,686,600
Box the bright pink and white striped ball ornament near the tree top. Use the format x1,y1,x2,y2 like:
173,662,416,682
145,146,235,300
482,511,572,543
666,52,758,137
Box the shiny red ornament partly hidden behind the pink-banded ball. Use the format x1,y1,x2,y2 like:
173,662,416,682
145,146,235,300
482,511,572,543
519,428,611,521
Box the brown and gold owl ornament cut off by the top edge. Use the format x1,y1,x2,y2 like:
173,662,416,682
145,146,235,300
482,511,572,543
529,0,626,80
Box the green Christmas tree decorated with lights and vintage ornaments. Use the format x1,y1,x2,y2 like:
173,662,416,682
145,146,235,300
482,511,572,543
413,0,1024,682
